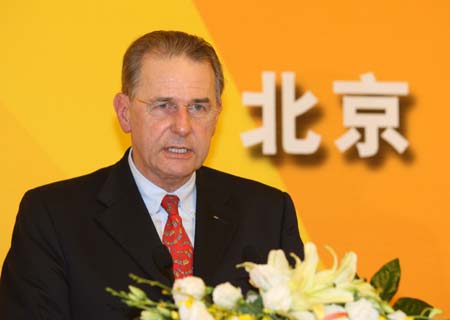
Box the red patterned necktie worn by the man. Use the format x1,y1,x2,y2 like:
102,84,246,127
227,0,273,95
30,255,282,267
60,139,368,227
161,194,194,279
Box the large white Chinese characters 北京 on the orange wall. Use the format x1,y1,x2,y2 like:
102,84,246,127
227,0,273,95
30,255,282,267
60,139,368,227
241,72,409,158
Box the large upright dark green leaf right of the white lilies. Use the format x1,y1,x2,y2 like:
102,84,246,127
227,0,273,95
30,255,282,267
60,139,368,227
370,259,400,302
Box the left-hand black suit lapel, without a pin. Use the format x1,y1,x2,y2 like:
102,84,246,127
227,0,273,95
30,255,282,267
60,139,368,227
95,152,170,284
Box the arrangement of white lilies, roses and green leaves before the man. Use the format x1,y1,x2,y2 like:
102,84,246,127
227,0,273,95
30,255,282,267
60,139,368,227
107,243,441,320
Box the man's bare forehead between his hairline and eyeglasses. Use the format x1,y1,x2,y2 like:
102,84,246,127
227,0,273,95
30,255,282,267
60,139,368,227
136,54,215,99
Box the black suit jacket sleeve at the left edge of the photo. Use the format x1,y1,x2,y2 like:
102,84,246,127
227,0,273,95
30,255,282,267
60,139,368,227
0,190,70,320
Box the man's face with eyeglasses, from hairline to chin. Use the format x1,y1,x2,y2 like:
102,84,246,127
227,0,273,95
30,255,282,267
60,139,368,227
115,55,220,191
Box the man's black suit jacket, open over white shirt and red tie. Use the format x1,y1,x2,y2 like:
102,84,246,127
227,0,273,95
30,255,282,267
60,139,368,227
0,154,303,320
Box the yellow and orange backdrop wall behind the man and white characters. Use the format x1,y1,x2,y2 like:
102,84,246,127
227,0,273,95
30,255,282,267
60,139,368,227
0,0,450,314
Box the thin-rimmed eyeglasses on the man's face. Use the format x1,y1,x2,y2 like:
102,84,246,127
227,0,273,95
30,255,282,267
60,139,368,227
136,98,218,120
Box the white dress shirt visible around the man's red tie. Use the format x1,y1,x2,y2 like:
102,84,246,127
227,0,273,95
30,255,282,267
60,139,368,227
128,149,197,246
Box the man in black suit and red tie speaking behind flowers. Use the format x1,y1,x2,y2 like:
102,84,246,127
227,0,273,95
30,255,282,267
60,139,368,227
0,31,303,320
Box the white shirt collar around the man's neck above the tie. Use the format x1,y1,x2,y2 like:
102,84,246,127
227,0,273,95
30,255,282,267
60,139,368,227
128,149,196,215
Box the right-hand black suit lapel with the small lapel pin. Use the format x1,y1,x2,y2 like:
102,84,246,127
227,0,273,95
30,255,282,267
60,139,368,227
194,168,236,284
